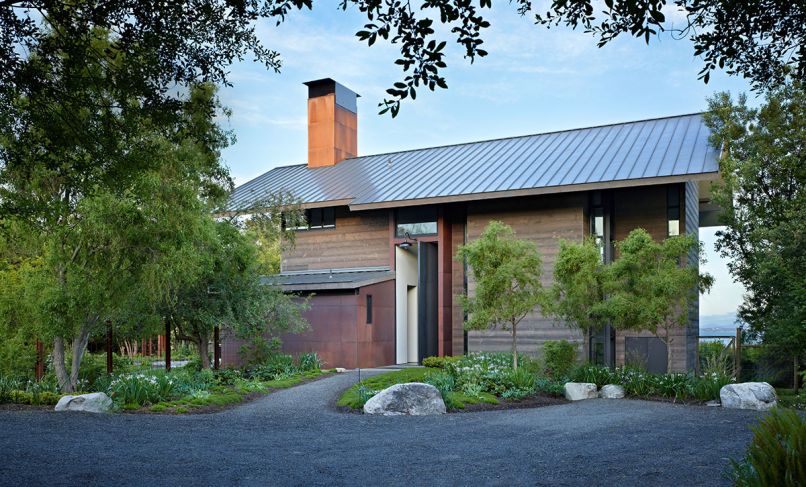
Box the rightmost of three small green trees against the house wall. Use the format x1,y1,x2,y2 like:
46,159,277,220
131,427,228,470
602,228,713,372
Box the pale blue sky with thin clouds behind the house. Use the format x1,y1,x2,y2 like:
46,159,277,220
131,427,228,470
220,0,749,315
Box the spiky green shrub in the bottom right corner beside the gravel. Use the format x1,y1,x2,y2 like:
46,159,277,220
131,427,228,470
729,410,806,487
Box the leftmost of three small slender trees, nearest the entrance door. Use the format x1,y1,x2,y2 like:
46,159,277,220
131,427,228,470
457,221,545,369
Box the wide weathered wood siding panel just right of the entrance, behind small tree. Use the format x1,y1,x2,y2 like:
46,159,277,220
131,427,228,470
467,193,587,356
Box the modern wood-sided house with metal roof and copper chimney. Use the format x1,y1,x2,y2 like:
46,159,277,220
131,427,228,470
223,79,718,371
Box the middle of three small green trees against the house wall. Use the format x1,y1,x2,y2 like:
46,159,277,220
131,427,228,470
546,239,606,333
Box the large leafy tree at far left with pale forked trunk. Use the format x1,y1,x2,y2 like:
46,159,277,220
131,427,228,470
0,29,231,392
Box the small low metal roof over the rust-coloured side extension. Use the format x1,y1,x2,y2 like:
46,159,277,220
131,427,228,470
263,268,395,291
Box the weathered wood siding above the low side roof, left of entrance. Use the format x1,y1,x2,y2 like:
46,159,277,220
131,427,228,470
281,208,389,271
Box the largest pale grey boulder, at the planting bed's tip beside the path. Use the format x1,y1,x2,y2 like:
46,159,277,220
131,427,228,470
364,382,445,416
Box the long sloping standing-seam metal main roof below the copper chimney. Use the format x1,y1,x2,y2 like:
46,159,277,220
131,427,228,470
230,114,719,210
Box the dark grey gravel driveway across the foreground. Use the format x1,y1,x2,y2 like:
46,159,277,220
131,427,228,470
0,372,756,486
